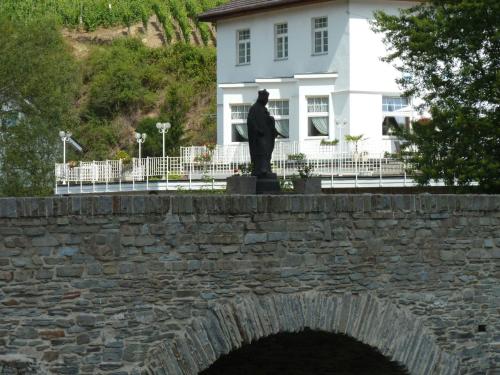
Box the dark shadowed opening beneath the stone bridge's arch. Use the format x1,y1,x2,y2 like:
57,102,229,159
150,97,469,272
200,329,408,375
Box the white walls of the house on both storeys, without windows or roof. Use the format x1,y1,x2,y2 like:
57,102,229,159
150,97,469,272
217,0,414,151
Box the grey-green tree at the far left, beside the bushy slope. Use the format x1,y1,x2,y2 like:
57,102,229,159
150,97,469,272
0,17,79,195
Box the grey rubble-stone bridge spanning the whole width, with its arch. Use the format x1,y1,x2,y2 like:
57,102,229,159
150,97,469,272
0,194,500,375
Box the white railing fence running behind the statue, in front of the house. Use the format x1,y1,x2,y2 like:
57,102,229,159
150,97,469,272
55,147,405,187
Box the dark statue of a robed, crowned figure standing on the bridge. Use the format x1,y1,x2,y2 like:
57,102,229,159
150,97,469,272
247,90,278,178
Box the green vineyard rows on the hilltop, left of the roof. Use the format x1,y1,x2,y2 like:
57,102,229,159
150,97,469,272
0,0,227,45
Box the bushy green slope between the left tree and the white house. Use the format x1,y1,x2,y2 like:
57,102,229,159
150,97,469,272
74,38,215,160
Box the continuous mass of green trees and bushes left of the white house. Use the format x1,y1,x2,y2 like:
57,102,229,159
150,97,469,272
0,18,216,195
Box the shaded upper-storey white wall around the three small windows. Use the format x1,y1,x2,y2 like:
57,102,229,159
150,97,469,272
217,0,349,88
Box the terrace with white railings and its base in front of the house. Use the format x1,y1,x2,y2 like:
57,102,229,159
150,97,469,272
55,142,430,194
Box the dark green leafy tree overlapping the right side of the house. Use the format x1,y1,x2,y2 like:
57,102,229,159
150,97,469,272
374,0,500,191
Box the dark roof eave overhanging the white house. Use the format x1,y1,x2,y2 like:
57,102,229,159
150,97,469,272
198,0,328,22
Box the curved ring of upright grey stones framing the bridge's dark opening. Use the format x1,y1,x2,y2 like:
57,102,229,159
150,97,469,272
143,292,459,375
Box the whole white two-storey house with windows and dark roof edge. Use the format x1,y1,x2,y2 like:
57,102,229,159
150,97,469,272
200,0,415,154
